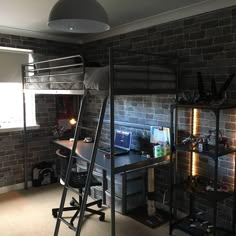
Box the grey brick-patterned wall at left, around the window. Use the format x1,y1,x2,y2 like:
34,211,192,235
0,34,80,187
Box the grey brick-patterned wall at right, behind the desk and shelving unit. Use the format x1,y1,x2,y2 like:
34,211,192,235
84,6,236,226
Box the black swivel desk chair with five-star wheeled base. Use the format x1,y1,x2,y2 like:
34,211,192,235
52,149,105,226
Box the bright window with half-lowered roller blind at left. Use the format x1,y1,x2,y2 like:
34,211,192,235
0,47,37,129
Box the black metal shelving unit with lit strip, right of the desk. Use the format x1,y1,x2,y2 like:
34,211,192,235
169,104,236,236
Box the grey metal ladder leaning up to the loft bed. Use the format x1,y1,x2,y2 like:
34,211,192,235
54,92,108,236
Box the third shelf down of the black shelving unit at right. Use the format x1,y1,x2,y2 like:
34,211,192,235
174,183,234,204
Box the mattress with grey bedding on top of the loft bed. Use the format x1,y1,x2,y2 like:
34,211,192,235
25,65,176,90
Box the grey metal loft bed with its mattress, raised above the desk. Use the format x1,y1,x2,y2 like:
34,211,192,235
22,49,179,236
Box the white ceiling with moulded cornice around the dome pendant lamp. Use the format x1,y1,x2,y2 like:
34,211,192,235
0,0,236,43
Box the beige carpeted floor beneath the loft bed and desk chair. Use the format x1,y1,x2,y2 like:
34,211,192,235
0,184,186,236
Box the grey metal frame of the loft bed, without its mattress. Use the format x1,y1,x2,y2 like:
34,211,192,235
22,49,179,236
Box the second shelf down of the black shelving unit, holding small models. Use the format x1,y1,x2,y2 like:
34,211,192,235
175,144,236,159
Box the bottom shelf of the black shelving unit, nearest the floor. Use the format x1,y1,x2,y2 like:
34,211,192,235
172,217,234,236
